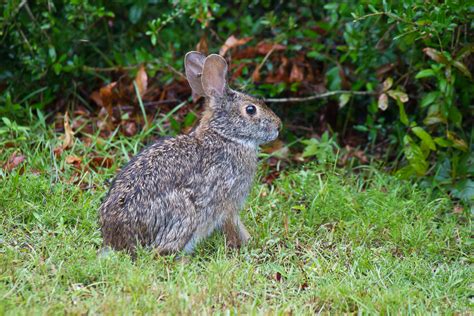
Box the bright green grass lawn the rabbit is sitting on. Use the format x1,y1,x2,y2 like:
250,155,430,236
0,121,473,315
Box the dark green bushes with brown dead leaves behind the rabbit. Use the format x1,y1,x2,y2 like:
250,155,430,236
0,0,474,203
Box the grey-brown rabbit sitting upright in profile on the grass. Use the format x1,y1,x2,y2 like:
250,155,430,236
99,51,281,255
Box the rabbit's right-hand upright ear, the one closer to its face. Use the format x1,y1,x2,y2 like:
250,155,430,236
201,54,227,96
